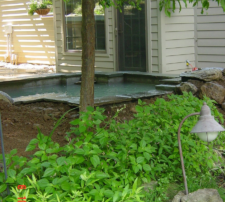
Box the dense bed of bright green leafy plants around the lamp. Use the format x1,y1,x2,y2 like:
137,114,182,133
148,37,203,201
0,93,225,202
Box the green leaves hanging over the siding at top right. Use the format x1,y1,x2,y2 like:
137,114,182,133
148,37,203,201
159,0,225,17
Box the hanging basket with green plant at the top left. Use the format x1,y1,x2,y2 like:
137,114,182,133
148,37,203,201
28,0,52,15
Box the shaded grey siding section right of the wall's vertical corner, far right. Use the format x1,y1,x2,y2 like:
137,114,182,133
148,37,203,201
196,2,225,68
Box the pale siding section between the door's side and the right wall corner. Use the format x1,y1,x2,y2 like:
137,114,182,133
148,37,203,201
159,2,195,74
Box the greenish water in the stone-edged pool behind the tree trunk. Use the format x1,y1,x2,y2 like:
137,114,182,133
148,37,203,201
5,83,155,98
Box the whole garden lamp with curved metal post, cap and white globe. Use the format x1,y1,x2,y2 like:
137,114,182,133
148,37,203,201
177,102,225,195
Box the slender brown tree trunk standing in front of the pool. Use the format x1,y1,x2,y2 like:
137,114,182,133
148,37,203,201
80,0,95,112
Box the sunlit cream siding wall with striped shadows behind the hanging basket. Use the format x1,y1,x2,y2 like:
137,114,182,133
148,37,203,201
0,0,55,64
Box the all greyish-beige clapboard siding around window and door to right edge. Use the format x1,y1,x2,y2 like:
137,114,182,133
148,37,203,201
54,0,225,74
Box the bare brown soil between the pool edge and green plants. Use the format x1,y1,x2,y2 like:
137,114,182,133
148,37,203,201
0,96,168,156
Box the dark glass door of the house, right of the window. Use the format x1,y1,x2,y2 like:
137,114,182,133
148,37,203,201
117,1,146,72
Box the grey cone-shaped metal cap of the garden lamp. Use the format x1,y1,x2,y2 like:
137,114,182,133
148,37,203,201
191,102,225,133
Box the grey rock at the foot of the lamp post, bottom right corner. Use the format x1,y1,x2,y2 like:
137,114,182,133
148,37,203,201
181,189,223,202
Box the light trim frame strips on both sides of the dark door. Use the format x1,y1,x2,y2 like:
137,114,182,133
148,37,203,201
114,0,152,73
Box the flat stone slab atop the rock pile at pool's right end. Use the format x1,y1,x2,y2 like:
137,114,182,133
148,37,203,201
180,68,223,81
